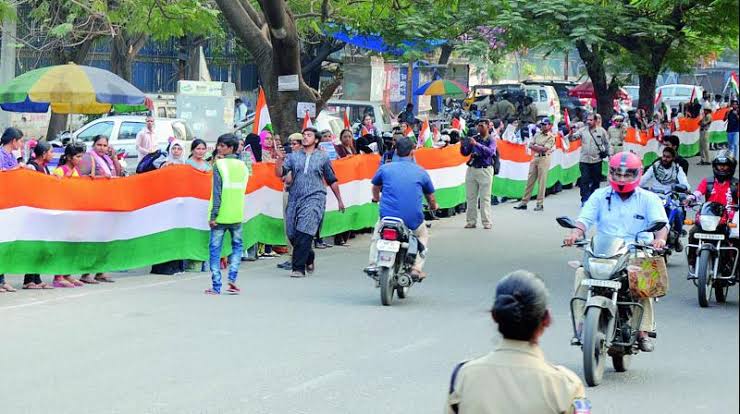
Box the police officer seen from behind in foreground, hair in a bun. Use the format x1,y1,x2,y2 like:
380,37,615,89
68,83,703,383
445,270,586,414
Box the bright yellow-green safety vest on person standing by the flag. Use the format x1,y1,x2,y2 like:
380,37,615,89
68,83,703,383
208,158,249,224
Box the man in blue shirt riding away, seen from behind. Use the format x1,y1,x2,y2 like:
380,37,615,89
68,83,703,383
365,139,438,280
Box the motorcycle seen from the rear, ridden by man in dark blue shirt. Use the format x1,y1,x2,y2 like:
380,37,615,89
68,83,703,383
367,217,426,306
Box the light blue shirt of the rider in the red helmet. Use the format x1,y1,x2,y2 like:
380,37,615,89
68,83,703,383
578,187,668,243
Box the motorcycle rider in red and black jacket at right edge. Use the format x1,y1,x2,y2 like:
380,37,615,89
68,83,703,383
687,150,739,273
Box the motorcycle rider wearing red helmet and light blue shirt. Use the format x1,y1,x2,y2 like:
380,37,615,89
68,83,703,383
564,152,668,352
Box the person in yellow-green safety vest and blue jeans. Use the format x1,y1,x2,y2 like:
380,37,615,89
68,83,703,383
205,134,249,295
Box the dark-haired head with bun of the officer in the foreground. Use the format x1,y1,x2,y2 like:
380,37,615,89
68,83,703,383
491,270,548,341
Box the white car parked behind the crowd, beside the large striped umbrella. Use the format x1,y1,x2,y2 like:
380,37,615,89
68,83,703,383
72,115,194,158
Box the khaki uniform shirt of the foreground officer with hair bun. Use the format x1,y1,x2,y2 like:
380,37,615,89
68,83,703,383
445,339,586,414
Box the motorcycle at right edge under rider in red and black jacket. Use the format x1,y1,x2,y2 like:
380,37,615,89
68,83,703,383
685,202,740,308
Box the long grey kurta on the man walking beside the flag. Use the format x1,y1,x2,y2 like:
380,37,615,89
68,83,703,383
283,150,337,239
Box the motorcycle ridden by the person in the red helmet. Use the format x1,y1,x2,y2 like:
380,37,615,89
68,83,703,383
556,217,666,386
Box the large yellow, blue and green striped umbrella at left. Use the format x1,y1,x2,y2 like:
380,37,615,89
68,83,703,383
0,63,144,114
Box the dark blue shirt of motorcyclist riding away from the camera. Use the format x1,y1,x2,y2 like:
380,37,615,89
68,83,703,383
372,157,434,230
